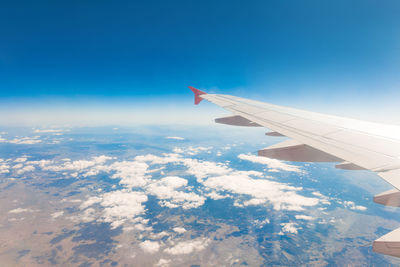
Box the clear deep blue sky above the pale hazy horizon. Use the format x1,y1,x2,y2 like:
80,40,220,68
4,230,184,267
0,0,400,125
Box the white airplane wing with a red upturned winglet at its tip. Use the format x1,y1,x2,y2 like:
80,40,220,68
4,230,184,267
189,86,400,257
